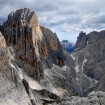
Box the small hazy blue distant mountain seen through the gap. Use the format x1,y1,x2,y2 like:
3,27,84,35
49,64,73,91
61,40,74,53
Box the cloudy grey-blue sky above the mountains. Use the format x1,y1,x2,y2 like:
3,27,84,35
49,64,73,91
0,0,105,42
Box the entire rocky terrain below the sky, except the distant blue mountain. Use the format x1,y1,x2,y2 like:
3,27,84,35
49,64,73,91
0,8,105,105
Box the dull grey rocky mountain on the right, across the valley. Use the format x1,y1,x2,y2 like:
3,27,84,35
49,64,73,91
72,31,105,91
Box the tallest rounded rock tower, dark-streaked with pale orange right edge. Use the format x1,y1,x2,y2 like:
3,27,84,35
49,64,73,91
2,8,43,80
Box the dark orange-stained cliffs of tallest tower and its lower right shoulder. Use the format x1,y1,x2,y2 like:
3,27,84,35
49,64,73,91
2,8,65,80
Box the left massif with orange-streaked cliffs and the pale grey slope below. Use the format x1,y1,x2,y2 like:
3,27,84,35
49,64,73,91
2,8,88,100
